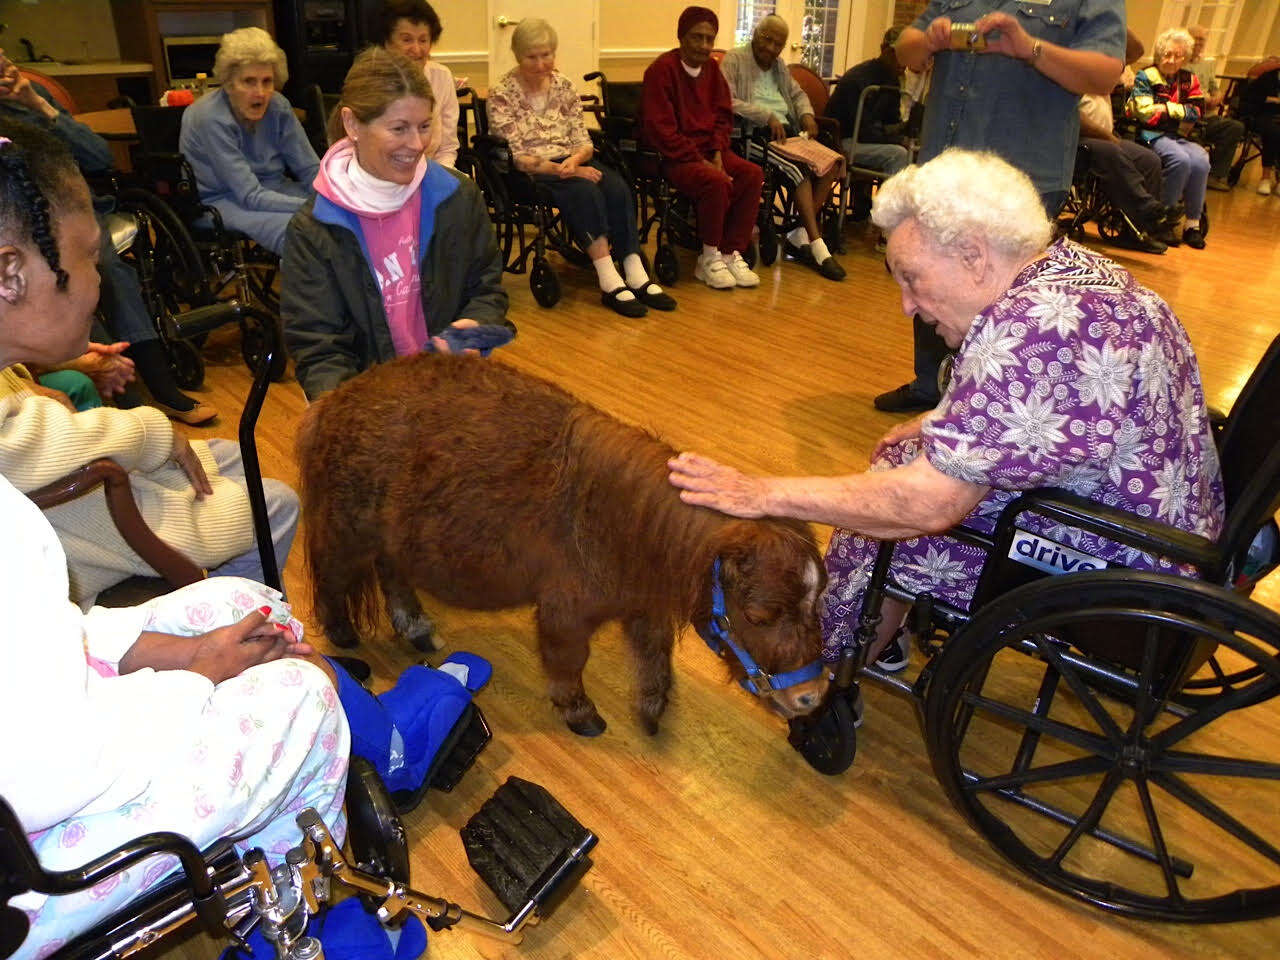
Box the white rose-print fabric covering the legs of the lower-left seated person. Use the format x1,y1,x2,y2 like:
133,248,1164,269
13,577,351,960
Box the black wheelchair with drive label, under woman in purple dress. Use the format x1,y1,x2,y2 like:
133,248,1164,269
790,337,1280,923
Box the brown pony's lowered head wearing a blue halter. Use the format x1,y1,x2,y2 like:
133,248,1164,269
696,520,827,718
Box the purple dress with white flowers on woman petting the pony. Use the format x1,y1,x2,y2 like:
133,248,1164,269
822,241,1225,660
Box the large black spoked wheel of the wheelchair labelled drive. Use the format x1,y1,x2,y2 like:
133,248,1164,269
925,570,1280,923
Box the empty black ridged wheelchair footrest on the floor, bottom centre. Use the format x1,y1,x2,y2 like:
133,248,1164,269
461,777,596,916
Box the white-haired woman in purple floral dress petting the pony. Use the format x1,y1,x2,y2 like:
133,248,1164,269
672,150,1224,716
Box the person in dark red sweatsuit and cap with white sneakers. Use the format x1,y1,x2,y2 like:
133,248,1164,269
640,6,764,289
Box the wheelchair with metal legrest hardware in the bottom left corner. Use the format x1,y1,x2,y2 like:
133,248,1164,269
0,758,596,960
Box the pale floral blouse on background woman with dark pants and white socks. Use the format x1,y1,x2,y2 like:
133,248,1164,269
488,70,591,160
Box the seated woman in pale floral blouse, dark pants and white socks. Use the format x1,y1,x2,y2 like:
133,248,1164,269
488,18,676,317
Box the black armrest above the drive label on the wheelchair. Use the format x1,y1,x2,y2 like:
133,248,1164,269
997,488,1222,577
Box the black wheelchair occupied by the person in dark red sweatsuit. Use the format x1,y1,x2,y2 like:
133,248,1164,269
582,70,762,285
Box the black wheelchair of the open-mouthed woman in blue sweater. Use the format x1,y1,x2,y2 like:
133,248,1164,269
116,106,287,388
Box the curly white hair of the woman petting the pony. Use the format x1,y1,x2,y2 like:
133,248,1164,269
872,147,1053,259
